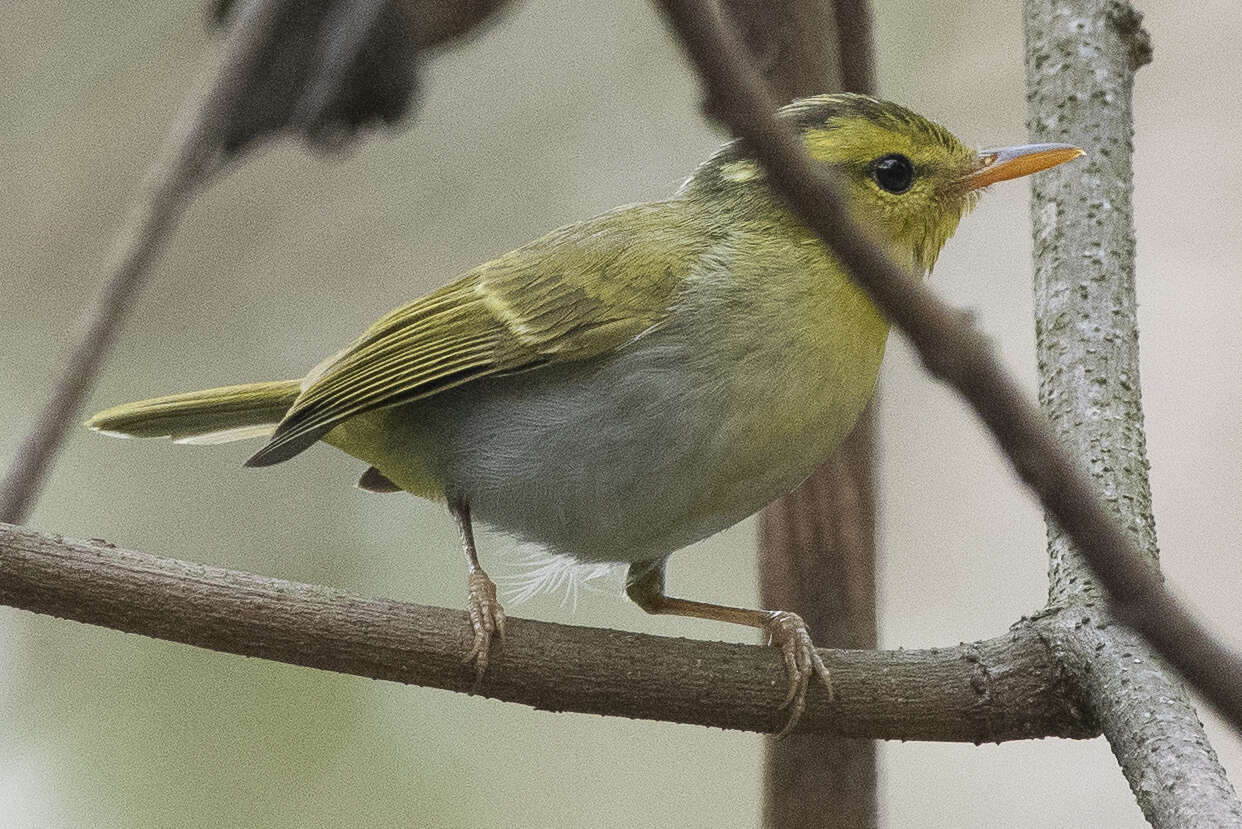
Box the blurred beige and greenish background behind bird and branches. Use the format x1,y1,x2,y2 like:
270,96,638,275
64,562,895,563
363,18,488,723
0,0,1242,827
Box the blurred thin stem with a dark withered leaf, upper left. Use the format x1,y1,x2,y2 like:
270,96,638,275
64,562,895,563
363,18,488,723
0,0,509,523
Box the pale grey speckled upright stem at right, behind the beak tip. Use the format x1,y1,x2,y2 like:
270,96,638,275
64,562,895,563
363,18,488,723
1026,0,1242,827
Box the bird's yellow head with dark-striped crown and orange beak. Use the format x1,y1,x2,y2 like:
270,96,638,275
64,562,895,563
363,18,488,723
683,94,1083,272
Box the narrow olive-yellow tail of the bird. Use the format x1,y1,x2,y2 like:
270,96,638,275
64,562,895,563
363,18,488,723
86,380,302,444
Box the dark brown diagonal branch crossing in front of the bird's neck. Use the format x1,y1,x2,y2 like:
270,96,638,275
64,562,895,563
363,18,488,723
660,0,1242,730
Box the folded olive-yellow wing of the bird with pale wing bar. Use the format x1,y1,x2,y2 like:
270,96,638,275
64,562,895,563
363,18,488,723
247,201,702,466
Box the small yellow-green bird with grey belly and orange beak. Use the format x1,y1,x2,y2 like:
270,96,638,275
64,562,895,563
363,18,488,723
87,93,1083,733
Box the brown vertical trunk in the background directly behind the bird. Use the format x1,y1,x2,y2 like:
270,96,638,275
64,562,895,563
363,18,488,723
725,0,876,829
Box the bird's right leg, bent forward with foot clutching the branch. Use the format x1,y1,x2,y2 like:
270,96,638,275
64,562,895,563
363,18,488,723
625,562,832,737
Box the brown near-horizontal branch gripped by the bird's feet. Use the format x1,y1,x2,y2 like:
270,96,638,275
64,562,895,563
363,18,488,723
0,524,1097,742
